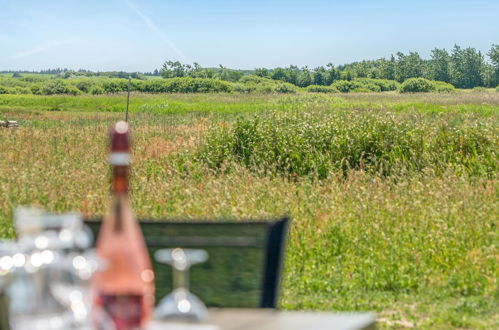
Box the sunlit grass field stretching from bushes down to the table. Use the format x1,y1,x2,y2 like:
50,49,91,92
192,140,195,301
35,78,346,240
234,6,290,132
0,92,499,329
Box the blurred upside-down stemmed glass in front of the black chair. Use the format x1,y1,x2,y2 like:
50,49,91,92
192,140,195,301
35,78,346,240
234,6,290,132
154,248,208,321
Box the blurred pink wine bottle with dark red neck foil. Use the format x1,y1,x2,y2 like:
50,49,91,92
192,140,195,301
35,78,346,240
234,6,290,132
93,121,154,330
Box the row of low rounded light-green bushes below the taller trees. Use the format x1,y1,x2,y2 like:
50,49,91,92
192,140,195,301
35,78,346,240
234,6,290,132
0,75,454,95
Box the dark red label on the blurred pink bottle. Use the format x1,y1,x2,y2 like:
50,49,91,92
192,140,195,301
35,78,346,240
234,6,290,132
100,295,143,330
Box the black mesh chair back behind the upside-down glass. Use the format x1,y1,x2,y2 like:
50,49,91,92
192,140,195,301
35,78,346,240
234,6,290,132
86,218,289,308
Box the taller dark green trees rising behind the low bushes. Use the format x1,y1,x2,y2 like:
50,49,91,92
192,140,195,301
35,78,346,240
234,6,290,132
160,45,499,88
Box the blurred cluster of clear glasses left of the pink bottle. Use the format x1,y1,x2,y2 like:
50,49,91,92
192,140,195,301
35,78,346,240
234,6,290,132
7,207,95,329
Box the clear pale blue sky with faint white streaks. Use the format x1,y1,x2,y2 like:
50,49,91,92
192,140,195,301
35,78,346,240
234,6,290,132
0,0,499,71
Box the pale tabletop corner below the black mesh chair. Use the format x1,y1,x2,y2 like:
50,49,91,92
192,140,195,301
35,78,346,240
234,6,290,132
149,308,376,330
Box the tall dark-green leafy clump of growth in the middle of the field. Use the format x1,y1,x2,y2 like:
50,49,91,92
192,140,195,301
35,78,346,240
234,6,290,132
198,111,499,179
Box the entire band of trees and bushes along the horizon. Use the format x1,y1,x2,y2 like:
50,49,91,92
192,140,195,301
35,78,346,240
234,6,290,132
0,45,499,95
